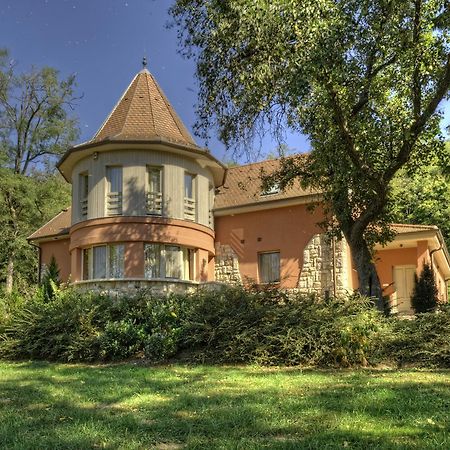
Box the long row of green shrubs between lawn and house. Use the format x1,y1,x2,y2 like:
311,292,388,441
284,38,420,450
0,288,450,367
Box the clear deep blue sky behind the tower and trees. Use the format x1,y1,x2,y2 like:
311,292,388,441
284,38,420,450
0,0,450,162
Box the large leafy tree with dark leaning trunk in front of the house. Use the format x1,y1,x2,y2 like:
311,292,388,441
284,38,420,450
171,0,450,308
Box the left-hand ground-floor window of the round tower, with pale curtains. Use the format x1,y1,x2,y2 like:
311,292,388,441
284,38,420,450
83,244,124,280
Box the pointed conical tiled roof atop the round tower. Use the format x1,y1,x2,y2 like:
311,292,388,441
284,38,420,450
90,69,196,146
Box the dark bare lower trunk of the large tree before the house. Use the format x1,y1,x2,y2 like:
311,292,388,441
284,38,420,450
347,238,384,311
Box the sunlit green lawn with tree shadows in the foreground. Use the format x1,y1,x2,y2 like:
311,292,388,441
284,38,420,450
0,363,450,450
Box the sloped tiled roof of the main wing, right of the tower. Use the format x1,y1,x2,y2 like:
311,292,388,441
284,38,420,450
214,159,315,210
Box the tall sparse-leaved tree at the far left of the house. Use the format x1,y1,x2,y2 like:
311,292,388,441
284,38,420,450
0,50,78,292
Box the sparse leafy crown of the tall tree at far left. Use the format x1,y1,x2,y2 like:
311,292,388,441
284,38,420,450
0,50,78,175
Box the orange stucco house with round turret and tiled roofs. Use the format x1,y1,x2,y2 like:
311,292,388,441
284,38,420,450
29,68,450,313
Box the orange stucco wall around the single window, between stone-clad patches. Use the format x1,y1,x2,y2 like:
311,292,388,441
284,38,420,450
215,205,323,288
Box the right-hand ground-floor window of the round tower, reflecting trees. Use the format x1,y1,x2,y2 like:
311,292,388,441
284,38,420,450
144,244,195,280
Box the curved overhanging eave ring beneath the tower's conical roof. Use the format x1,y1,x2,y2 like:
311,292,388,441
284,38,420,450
56,137,226,187
